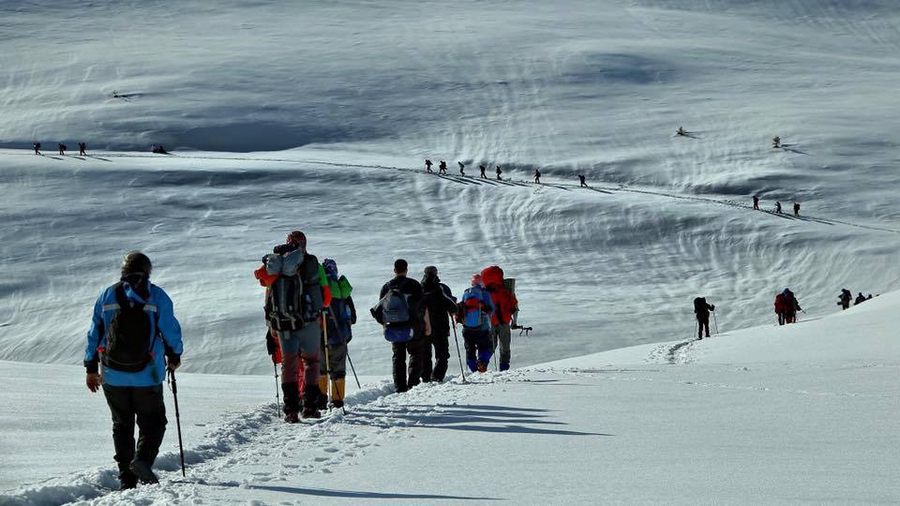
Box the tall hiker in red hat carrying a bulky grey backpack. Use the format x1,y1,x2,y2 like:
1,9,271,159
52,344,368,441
254,230,331,423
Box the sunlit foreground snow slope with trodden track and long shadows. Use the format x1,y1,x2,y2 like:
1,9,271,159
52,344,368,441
0,292,900,504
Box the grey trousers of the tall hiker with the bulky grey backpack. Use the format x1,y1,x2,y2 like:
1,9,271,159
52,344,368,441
278,322,322,414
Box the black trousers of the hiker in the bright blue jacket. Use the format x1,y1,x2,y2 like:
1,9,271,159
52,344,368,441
103,385,168,483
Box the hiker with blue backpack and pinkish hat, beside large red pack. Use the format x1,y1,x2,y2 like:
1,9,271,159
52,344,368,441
456,274,494,372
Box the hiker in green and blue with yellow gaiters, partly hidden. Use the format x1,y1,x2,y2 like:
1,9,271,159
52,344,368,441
317,258,356,410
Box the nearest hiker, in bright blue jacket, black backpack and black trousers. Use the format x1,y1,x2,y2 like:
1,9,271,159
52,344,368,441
84,251,183,490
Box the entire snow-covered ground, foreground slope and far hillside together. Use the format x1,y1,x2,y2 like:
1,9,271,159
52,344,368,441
0,0,900,505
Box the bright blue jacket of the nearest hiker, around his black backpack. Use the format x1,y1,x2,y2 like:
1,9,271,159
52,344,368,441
84,282,183,387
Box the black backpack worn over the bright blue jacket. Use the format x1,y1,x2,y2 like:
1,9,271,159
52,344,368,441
101,283,156,372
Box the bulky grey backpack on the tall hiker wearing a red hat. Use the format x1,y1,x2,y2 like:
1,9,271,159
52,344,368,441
264,250,322,330
